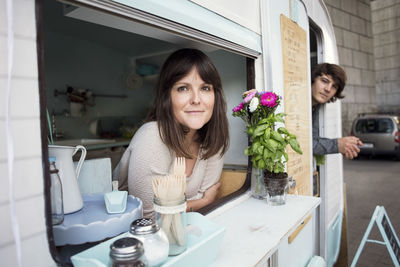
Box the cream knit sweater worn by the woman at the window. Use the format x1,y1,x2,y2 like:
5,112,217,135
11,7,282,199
113,122,223,217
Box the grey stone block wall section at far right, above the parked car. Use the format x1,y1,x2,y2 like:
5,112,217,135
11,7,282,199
371,0,400,113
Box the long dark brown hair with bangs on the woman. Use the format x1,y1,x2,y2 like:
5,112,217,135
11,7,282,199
146,48,229,159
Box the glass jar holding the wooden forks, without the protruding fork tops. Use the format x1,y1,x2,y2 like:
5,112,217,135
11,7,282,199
154,195,187,256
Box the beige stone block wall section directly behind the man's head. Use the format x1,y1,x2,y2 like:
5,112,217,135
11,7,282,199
324,0,377,136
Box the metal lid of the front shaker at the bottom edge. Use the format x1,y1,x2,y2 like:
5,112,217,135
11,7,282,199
110,237,144,261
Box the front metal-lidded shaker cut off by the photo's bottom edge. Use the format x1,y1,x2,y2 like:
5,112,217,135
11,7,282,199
109,237,147,267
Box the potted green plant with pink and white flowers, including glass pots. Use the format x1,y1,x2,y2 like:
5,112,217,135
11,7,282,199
233,89,303,205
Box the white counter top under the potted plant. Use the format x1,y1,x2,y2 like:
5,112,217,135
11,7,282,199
207,193,321,267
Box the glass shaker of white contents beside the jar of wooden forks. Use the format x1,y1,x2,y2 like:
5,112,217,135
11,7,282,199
129,218,169,266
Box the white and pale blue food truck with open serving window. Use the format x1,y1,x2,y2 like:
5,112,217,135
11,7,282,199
0,0,344,266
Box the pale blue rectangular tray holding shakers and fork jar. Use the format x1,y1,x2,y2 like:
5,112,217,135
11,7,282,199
71,212,225,267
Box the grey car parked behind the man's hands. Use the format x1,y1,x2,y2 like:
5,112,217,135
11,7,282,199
351,114,400,160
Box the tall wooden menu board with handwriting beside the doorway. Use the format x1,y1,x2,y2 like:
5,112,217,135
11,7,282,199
281,15,311,195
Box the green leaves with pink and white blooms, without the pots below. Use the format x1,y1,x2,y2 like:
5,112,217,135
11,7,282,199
233,89,303,173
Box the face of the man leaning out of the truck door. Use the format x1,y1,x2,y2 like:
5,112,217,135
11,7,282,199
312,74,337,106
